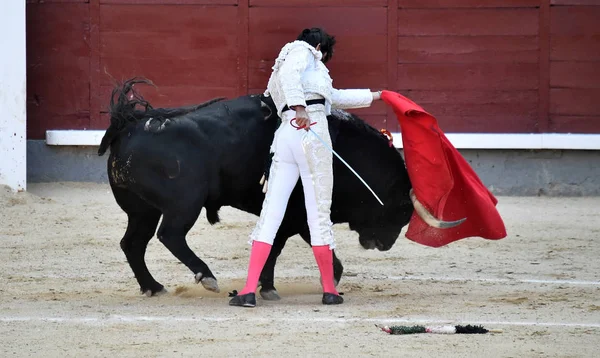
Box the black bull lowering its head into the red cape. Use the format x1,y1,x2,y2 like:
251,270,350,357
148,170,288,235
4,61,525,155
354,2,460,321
98,79,458,299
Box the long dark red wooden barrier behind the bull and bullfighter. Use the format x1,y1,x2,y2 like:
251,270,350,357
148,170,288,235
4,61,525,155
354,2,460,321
27,0,600,139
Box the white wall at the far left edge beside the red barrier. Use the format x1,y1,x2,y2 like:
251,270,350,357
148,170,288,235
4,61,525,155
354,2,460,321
0,0,27,191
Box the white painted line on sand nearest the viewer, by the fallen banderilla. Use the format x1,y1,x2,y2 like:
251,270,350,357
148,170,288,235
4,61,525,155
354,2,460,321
0,315,600,328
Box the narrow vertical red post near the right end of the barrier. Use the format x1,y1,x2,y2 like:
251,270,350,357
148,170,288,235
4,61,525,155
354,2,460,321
538,0,550,133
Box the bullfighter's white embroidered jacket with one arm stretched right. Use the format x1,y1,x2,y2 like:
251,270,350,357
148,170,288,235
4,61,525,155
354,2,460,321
265,41,373,117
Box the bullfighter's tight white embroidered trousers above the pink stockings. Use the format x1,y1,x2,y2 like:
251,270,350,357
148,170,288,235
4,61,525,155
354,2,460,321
250,104,335,250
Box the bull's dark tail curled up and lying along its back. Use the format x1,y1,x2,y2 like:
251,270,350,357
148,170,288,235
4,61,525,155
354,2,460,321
98,77,224,156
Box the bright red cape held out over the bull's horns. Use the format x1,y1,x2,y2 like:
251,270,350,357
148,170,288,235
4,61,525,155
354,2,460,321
381,91,506,247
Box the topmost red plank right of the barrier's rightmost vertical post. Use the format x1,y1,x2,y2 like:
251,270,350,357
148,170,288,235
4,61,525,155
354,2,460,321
550,6,600,36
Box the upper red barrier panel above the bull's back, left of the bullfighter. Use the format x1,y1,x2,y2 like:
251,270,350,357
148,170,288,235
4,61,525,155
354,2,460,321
100,5,239,88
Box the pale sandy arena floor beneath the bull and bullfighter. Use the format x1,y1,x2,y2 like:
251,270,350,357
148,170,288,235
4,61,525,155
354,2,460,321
0,183,600,358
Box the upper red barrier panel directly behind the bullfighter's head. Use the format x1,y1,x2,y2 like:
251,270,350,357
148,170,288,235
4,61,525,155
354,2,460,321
249,7,388,89
